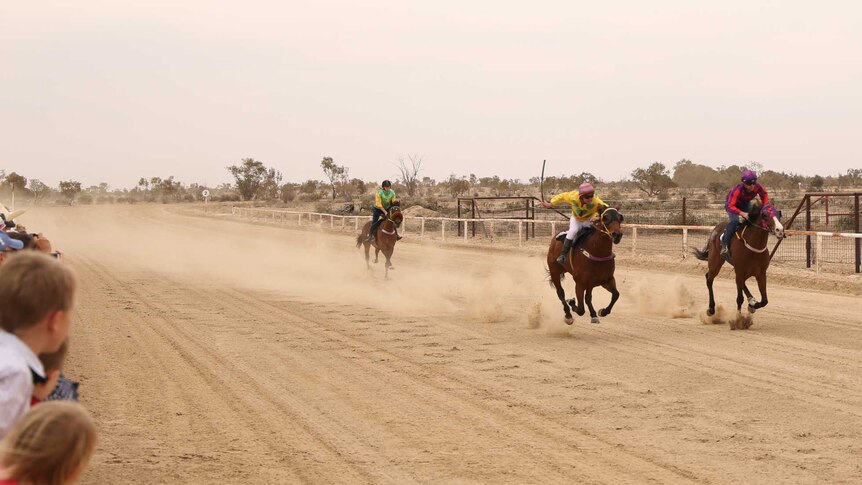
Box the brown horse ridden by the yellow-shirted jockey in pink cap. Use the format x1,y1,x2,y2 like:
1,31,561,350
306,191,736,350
548,208,623,325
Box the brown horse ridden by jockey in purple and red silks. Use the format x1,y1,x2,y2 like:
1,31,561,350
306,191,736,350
693,200,784,316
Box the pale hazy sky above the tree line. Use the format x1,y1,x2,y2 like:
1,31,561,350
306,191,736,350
0,0,862,187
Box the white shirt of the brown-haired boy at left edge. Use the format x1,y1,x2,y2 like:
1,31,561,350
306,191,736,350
0,330,45,439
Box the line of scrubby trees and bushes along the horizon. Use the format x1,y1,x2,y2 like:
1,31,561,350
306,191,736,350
0,153,862,206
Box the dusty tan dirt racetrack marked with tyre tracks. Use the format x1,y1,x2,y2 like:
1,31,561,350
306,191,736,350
20,205,862,484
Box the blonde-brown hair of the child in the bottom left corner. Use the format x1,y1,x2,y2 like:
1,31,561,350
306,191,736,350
0,401,96,485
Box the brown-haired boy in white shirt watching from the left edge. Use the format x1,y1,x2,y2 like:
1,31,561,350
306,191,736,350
0,251,76,438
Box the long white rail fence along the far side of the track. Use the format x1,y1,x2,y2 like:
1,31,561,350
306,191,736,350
231,207,862,272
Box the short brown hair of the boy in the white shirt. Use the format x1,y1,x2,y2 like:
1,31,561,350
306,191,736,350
0,251,76,333
